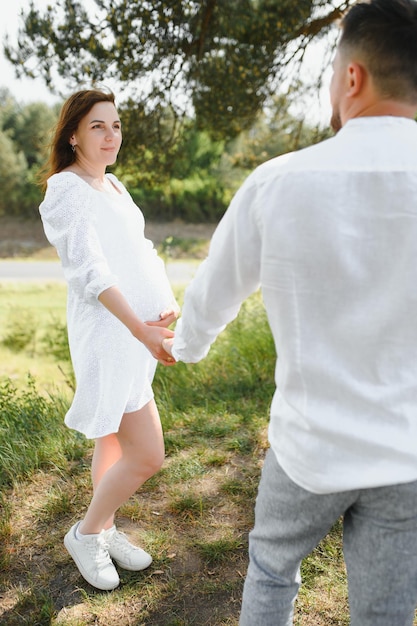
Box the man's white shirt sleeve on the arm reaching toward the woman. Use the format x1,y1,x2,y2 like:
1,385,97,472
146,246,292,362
172,169,261,363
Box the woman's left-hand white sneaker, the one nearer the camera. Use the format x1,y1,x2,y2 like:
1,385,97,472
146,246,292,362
64,522,120,591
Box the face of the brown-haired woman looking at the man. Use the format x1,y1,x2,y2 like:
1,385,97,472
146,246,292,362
70,102,122,167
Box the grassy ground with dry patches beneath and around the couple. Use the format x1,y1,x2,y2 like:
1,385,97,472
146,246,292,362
0,285,417,626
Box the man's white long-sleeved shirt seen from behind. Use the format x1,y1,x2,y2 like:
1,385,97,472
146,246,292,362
173,117,417,493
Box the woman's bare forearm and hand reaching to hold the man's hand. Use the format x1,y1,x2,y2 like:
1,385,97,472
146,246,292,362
98,287,175,365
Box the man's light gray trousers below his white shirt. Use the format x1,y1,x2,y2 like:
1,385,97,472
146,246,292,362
239,450,417,626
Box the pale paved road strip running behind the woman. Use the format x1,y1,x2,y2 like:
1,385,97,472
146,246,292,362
0,261,199,285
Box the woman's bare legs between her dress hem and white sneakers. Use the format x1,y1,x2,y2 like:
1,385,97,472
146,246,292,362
80,400,165,534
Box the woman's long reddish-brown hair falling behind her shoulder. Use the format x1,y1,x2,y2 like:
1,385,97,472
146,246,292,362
39,89,115,190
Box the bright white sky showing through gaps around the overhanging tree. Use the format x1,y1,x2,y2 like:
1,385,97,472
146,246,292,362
0,0,330,124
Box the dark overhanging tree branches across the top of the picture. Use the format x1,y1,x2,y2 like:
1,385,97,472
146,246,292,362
5,0,352,177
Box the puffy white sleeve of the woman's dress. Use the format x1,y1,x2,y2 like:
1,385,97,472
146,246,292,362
39,174,117,301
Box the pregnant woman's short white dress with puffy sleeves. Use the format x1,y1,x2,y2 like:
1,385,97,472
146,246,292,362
39,172,177,438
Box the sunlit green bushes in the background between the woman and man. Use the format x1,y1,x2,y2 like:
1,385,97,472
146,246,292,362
123,95,331,222
